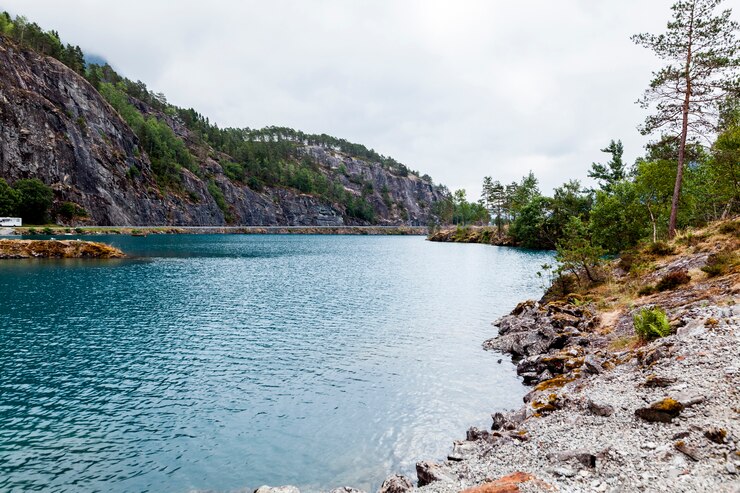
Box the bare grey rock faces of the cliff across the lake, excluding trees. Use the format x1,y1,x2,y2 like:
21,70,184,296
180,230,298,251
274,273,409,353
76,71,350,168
0,36,442,226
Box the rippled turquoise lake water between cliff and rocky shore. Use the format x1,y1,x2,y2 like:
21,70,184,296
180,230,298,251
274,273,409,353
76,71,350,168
0,235,551,492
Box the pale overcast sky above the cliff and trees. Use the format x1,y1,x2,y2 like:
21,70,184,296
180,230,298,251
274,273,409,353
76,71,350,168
0,0,728,199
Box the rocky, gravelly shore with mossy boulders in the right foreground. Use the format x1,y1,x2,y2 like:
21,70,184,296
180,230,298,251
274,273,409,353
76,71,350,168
381,223,740,493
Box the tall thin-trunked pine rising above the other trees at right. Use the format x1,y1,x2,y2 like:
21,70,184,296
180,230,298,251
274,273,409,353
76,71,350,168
632,0,740,238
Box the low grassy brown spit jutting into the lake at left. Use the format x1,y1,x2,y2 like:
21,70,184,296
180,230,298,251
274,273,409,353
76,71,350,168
0,240,126,260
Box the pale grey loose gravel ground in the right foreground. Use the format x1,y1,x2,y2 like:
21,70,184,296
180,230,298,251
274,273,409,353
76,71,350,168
421,304,740,493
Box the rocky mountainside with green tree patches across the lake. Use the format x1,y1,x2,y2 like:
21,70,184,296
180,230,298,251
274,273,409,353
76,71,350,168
0,27,444,226
